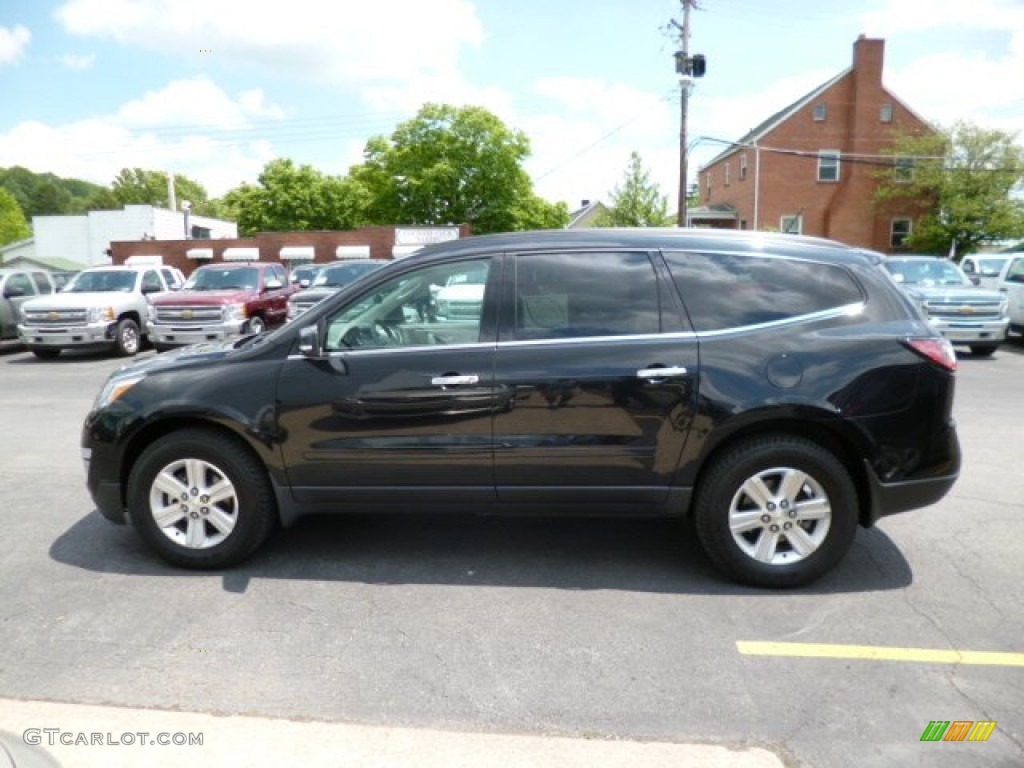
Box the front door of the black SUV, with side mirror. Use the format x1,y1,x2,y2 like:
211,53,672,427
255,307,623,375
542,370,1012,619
278,259,507,509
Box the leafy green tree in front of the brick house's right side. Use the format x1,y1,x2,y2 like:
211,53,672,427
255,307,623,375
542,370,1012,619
877,122,1024,255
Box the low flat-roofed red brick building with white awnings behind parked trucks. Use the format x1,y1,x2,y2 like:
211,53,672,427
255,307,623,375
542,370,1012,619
111,224,470,274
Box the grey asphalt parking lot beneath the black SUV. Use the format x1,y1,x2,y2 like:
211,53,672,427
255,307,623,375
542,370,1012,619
0,339,1024,767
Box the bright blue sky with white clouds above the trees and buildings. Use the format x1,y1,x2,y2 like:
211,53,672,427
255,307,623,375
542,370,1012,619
0,0,1024,210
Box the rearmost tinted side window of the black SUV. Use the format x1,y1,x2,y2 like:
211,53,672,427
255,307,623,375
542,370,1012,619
665,253,864,332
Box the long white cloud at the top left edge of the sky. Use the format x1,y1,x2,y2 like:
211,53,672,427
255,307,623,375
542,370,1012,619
55,0,483,83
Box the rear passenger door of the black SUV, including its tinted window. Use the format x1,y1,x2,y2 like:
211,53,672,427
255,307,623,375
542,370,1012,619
494,251,698,509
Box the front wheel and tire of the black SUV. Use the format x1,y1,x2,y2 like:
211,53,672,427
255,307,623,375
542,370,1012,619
128,429,278,568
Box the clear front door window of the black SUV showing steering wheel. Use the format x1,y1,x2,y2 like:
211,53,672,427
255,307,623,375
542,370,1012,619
326,259,490,352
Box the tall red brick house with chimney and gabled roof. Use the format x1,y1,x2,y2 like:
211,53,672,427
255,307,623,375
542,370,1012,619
688,35,933,253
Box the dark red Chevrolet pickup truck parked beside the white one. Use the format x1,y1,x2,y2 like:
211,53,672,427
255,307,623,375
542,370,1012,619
150,262,297,351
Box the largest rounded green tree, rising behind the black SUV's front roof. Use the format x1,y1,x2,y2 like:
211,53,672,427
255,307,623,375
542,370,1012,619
350,103,568,233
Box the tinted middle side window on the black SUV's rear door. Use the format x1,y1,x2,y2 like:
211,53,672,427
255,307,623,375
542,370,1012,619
503,252,660,340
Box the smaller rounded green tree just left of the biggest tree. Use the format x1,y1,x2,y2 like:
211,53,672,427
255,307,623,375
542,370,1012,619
218,159,370,234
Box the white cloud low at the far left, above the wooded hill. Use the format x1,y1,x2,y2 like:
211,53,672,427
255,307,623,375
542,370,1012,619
0,78,283,197
